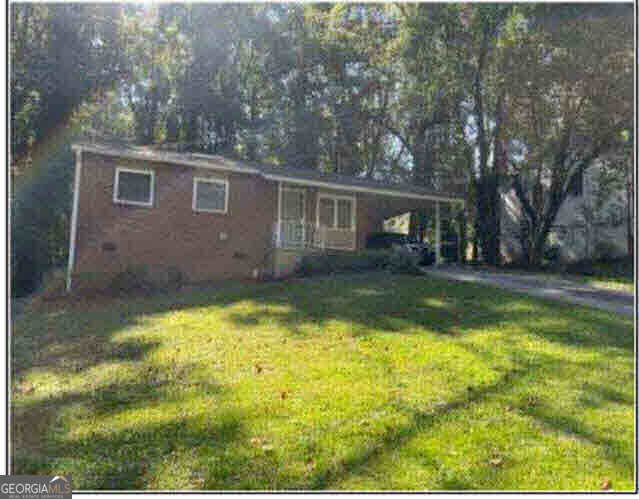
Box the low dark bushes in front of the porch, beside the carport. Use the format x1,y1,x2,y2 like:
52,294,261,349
296,250,390,276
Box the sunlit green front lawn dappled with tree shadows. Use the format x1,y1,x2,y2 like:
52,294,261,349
12,273,634,490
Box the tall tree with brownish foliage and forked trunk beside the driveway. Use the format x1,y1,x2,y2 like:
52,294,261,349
506,7,633,265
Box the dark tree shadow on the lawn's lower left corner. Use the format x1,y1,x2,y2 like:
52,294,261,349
12,362,235,489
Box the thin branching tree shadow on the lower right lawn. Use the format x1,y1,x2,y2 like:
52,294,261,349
309,348,634,490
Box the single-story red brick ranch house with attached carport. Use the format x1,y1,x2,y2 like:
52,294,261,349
67,144,463,290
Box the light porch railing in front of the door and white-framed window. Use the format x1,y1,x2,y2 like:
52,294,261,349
273,220,356,250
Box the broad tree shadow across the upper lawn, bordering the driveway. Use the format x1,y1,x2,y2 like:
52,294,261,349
225,277,634,351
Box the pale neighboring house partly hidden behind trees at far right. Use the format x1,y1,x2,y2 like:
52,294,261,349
501,163,628,262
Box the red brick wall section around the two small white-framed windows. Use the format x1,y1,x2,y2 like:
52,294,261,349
74,152,277,281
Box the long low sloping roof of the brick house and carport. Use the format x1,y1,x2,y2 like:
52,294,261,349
72,143,464,201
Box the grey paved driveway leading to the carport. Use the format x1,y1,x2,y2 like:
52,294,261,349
424,265,633,316
